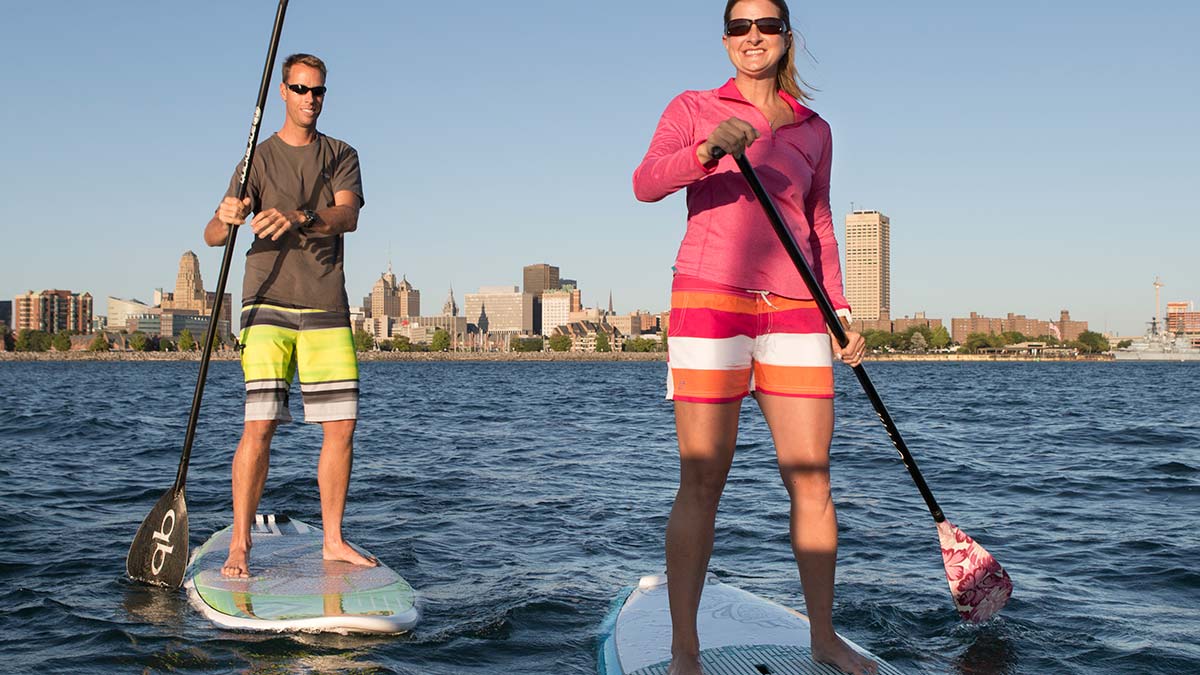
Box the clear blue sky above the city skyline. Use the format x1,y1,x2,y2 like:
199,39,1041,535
0,0,1200,334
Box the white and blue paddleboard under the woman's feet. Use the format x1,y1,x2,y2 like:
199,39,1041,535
600,574,901,675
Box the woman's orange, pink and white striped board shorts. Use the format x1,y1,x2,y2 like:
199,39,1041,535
667,274,833,404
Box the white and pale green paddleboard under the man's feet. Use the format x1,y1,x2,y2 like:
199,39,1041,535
184,515,420,633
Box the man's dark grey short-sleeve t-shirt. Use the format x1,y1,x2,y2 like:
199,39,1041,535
226,133,365,311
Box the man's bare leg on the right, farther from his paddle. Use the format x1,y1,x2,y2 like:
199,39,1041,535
317,419,379,567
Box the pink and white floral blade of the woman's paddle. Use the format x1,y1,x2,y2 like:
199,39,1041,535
937,520,1013,623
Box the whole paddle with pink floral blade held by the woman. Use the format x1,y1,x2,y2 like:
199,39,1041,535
712,148,1013,622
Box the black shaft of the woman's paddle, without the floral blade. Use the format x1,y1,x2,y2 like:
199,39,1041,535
712,147,946,522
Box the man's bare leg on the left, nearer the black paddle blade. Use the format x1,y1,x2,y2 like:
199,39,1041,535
221,420,280,578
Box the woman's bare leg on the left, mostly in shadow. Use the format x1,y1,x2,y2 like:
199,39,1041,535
666,401,742,675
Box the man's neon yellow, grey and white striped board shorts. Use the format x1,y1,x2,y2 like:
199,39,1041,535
241,304,359,422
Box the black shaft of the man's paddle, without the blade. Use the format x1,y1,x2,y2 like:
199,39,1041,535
174,0,288,491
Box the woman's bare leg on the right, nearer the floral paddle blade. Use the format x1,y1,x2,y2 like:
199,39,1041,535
757,395,878,675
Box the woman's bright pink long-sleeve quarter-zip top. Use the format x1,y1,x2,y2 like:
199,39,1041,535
634,79,850,313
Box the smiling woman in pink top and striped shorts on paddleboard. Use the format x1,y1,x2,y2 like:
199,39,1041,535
634,0,876,675
